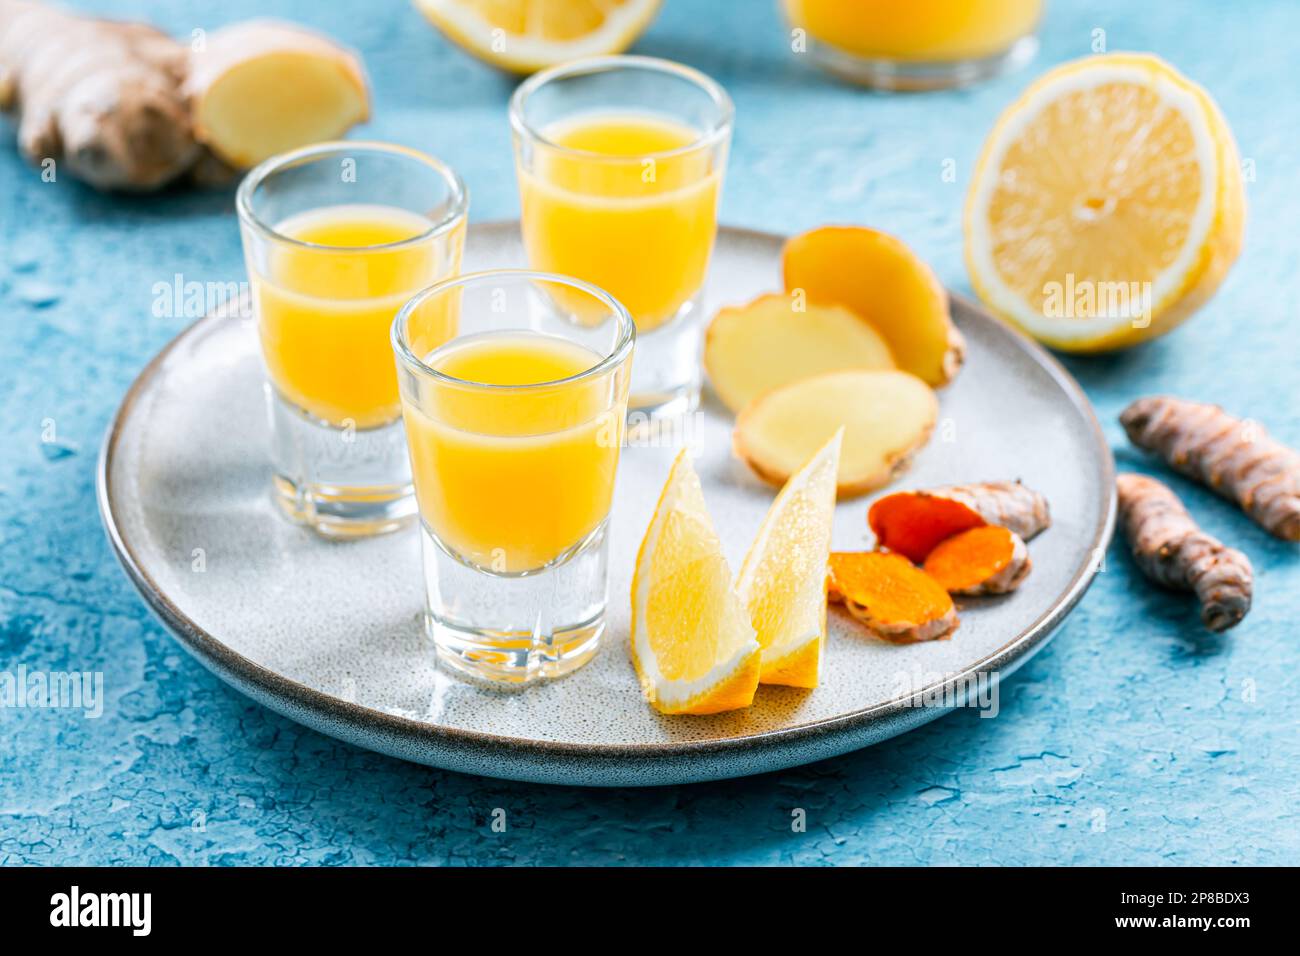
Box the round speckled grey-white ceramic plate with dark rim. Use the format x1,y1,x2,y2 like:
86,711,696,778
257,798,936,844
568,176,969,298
99,222,1114,786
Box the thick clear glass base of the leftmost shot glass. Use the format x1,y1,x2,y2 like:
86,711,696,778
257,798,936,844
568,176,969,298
267,382,416,537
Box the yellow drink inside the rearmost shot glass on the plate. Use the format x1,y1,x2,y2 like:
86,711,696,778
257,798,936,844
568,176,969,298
519,112,723,333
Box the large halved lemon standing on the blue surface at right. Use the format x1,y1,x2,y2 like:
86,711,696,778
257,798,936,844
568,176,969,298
965,53,1245,352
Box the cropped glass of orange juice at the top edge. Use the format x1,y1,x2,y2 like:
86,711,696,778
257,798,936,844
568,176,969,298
781,0,1044,90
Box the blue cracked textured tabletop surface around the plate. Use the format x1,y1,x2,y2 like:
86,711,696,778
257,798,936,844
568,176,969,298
0,0,1300,865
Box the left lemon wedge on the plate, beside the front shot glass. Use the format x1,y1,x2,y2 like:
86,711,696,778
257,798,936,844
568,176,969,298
632,450,762,714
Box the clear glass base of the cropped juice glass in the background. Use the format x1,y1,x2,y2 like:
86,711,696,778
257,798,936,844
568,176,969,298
800,34,1039,91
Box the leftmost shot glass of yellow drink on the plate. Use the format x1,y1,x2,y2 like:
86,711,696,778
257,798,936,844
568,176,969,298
237,142,468,537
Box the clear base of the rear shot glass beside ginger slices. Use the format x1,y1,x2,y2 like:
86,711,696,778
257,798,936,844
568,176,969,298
628,293,705,425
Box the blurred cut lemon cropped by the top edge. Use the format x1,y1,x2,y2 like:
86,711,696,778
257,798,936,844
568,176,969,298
415,0,662,73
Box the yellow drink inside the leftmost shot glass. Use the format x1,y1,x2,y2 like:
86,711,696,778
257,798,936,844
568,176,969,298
250,204,452,428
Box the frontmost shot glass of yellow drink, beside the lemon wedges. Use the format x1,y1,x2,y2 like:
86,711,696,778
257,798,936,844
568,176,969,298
393,271,636,684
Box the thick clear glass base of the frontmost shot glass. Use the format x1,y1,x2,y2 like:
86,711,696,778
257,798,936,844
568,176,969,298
420,523,608,685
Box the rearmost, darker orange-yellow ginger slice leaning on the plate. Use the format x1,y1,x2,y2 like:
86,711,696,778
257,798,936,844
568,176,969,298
781,226,966,388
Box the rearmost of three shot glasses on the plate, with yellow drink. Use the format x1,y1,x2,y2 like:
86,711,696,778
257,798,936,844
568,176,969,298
510,56,733,420
